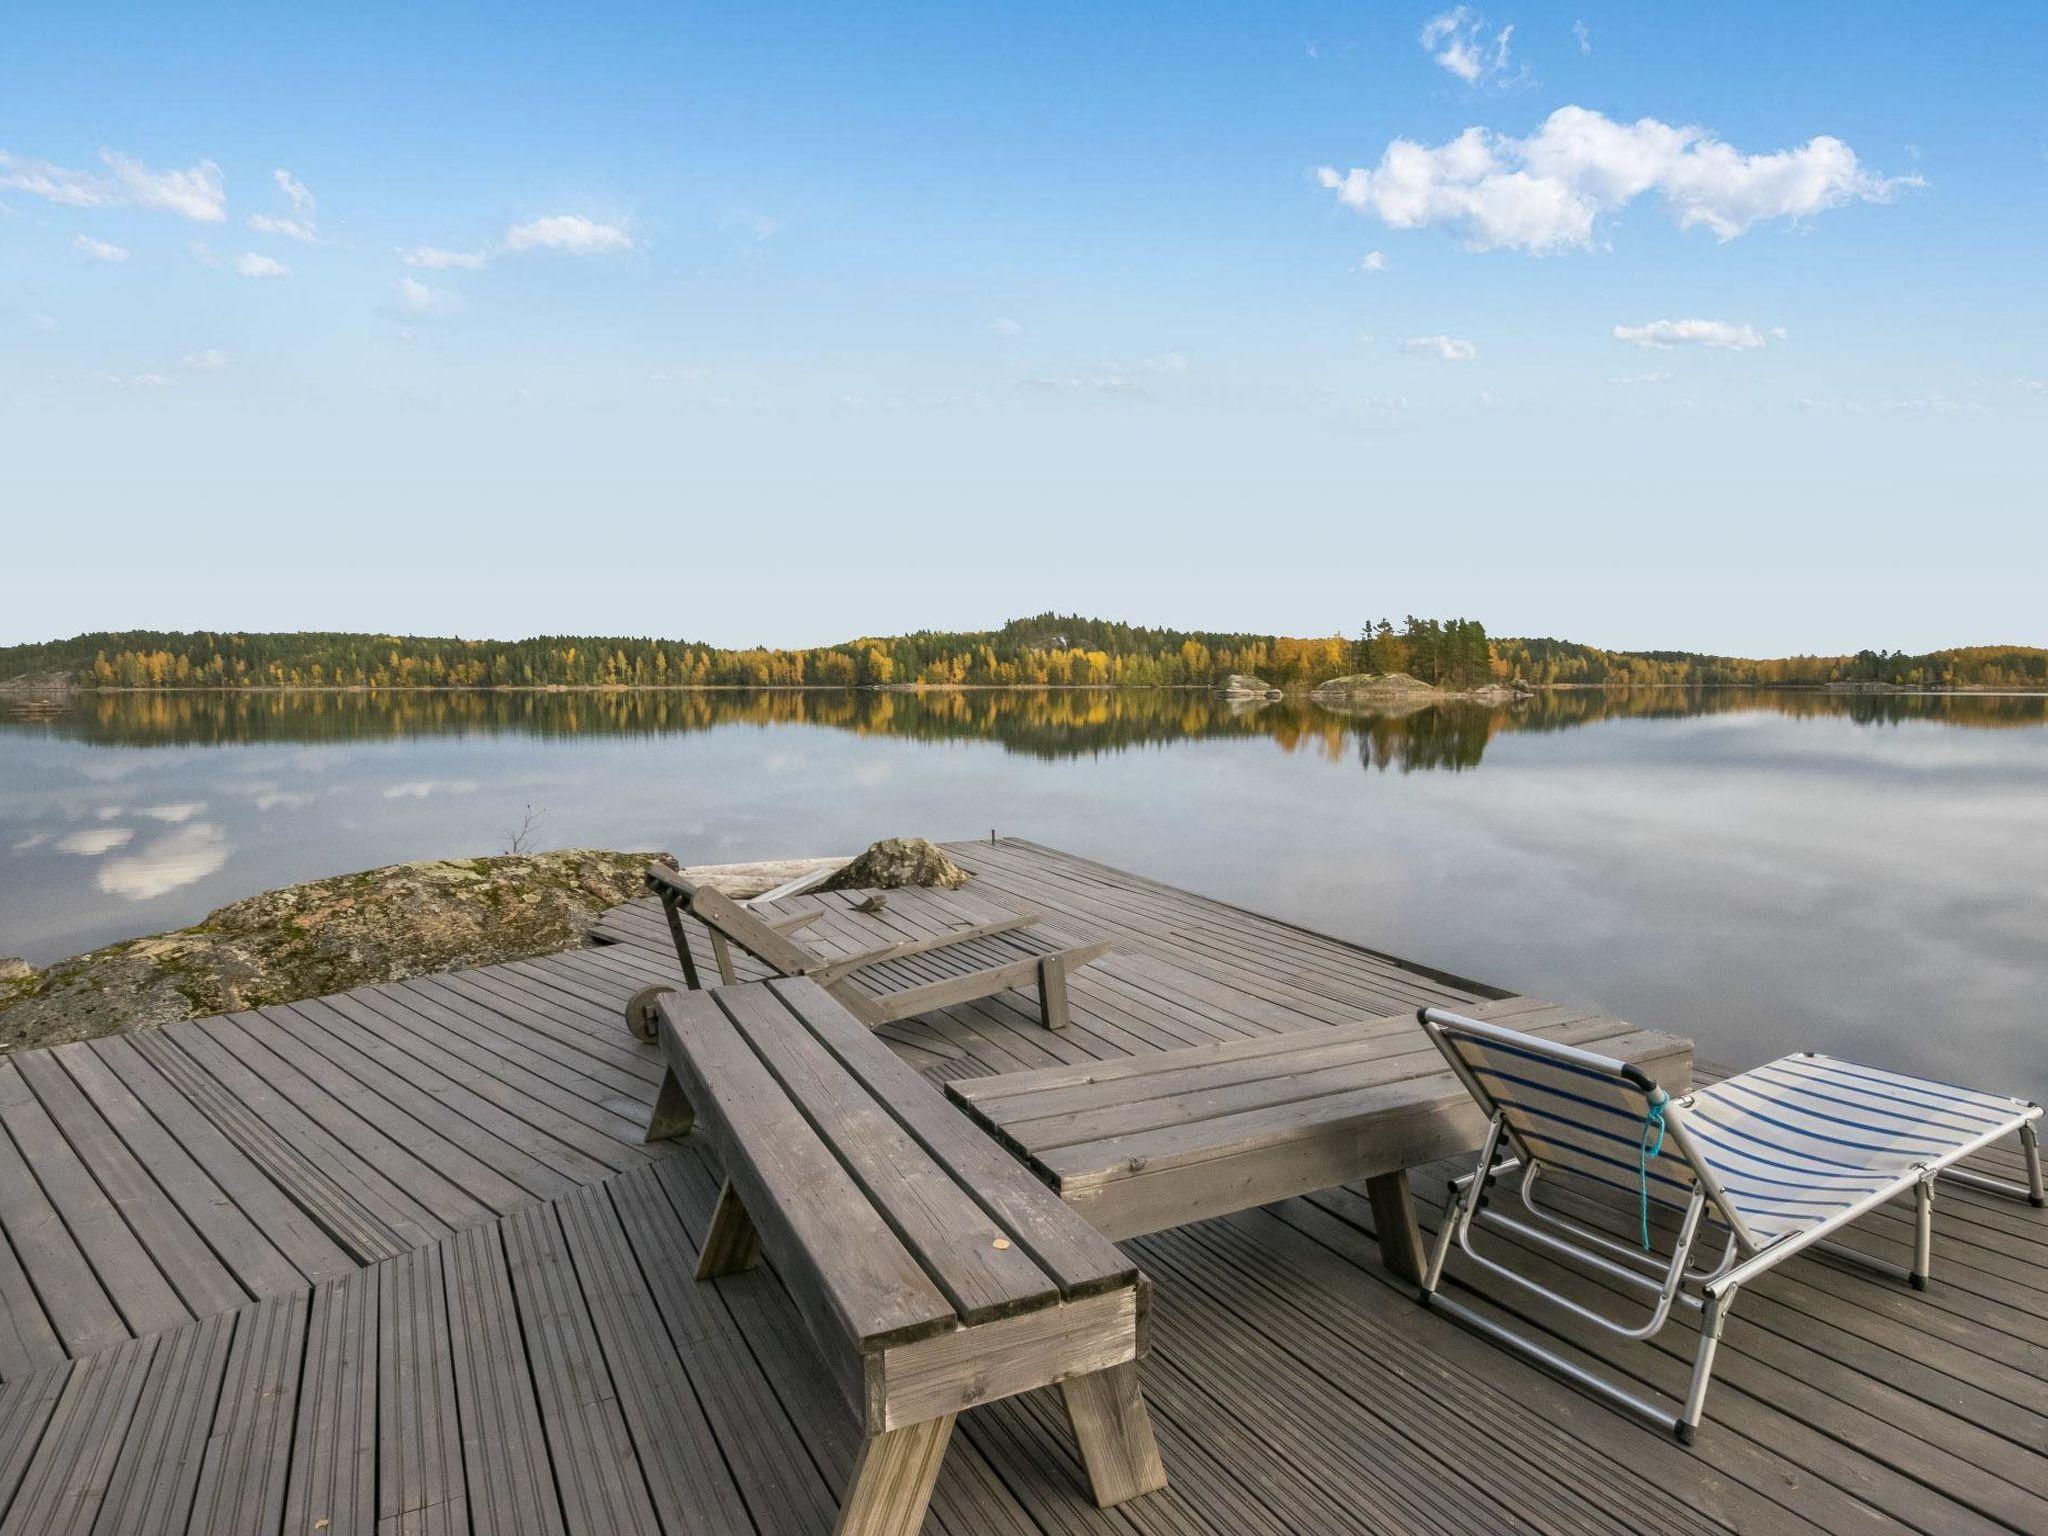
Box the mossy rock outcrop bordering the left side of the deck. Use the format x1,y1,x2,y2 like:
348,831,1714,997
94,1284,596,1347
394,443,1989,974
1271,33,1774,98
0,848,668,1049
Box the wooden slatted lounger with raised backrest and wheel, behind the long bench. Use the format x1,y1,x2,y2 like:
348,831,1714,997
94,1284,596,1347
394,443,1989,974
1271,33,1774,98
627,864,1110,1038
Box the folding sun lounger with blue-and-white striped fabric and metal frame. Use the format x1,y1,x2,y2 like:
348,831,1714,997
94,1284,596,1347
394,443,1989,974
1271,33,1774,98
1417,1008,2042,1444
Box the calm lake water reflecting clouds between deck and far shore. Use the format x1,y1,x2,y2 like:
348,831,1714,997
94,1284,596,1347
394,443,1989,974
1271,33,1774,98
0,690,2048,1096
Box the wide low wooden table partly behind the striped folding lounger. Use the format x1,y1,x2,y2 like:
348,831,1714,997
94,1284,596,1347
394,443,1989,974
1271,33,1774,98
946,997,1692,1282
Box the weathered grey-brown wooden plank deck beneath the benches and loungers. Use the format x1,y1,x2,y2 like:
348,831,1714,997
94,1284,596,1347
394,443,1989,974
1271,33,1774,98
0,840,2048,1536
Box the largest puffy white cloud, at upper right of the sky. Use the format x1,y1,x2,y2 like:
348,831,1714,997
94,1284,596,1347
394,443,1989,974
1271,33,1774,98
1317,106,1923,252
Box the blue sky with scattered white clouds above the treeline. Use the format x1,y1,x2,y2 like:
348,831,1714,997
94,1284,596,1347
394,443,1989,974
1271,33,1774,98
0,4,2048,653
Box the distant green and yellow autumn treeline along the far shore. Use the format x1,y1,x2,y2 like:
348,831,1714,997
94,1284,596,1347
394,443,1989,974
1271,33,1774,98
0,614,2048,688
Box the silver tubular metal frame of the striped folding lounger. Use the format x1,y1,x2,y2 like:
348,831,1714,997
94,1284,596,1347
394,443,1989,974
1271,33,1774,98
1415,1008,2044,1444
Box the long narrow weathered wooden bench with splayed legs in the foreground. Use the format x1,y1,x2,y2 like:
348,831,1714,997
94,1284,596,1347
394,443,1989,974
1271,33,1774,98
647,979,1165,1536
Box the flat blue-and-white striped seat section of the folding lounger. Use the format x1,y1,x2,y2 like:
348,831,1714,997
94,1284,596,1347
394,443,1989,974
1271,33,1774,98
1681,1057,2030,1247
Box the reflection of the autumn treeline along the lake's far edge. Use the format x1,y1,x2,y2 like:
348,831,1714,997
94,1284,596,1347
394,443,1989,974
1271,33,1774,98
19,688,2048,765
